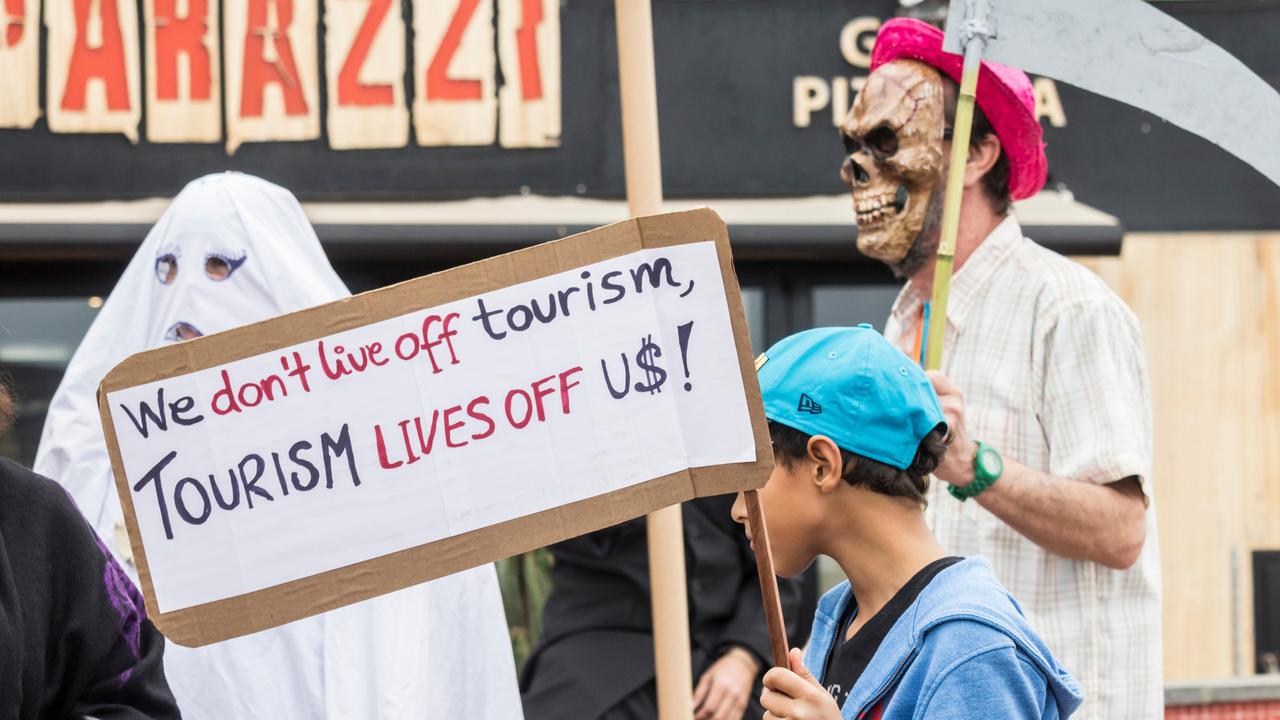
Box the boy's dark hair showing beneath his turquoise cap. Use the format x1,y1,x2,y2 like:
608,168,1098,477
769,420,951,505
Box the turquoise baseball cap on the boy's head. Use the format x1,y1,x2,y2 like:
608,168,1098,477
755,324,945,470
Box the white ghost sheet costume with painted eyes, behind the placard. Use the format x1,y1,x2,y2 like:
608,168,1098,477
35,173,522,720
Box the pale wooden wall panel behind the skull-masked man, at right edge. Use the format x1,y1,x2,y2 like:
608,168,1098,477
1084,233,1280,680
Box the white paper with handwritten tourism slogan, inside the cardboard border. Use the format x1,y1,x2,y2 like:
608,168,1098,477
108,242,755,612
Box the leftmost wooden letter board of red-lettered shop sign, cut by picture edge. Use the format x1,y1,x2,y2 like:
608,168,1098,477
0,0,40,129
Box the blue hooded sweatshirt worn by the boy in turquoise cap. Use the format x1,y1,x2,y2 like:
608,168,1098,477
804,557,1084,720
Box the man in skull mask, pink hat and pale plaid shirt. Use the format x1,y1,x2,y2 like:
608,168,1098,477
841,19,1164,720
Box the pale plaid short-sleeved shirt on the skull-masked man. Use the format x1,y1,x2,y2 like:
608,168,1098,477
884,217,1164,720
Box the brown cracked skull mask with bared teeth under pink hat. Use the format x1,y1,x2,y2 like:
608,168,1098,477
840,60,943,264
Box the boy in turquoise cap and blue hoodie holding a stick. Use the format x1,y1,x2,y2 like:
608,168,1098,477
733,325,1083,720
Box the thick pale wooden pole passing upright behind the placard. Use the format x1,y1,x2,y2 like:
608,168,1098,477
613,0,694,720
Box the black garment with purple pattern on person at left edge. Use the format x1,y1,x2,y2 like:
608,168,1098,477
0,459,179,720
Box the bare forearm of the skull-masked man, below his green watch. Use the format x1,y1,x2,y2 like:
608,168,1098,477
967,459,1147,570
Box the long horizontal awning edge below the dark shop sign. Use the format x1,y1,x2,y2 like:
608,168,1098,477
0,191,1124,260
